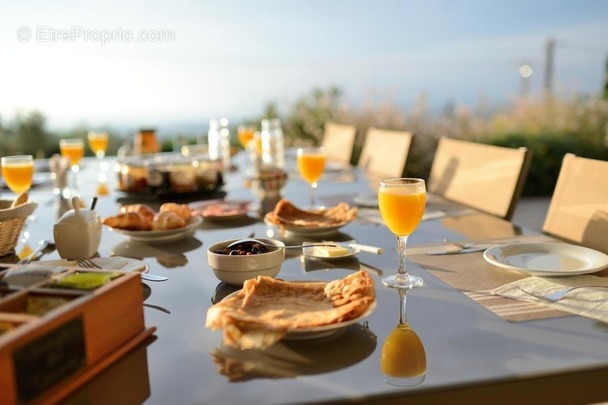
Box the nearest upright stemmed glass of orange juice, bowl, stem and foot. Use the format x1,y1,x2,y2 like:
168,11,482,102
378,178,426,289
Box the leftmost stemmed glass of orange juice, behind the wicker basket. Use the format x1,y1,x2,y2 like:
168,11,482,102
0,155,34,258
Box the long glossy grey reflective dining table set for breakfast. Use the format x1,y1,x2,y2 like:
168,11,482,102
13,154,608,404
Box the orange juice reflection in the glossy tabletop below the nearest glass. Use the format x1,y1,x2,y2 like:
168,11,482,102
380,324,426,378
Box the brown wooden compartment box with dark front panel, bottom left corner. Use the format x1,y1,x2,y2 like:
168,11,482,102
0,269,154,404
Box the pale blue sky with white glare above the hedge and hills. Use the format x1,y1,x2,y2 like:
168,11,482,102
0,0,608,132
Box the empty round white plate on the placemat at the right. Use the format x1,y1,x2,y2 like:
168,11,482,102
483,243,608,277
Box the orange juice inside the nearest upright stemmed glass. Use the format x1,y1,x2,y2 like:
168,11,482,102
378,187,426,236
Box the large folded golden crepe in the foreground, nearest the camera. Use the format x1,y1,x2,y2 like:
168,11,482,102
205,271,375,349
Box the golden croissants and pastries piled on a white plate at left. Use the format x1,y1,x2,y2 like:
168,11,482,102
103,203,192,231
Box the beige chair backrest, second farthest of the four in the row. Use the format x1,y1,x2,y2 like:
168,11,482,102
359,127,412,178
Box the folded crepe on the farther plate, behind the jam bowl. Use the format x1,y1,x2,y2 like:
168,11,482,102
265,198,357,232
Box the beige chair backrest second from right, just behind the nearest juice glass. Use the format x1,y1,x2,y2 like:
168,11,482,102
427,137,532,219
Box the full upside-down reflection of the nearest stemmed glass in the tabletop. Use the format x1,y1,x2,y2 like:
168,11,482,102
380,289,426,387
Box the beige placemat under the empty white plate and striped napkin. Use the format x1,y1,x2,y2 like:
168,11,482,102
408,235,608,322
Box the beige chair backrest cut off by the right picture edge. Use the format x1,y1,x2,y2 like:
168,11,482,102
543,154,608,253
